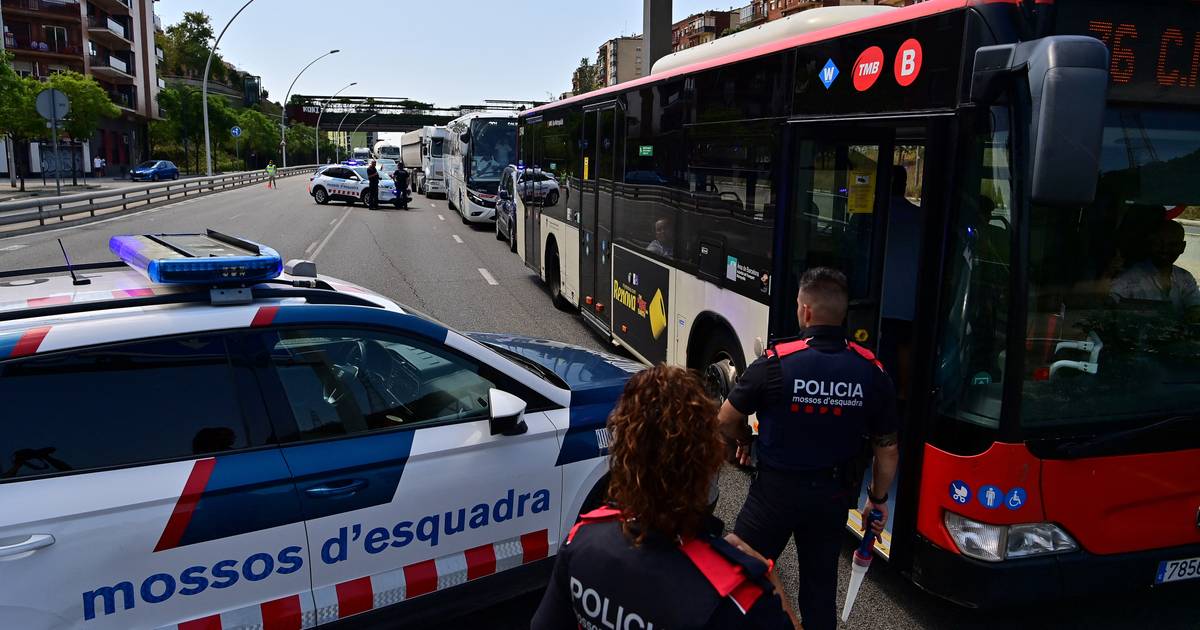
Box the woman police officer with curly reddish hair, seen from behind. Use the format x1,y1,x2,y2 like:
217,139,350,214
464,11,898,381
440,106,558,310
532,365,796,630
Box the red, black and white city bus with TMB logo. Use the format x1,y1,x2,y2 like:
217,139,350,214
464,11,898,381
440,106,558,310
516,0,1200,607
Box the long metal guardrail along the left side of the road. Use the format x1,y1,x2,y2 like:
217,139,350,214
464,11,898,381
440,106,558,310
0,164,317,236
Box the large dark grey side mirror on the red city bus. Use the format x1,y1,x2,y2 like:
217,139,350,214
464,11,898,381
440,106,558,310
1018,36,1109,206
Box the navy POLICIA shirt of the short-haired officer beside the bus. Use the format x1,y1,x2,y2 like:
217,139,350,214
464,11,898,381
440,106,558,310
728,326,899,472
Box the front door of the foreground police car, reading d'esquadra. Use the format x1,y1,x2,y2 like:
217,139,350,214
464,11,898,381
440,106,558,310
253,328,562,620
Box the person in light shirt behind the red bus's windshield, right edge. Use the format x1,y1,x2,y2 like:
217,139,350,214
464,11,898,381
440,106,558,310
1109,220,1200,323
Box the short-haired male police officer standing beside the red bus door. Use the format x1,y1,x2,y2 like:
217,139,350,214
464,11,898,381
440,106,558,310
720,268,899,630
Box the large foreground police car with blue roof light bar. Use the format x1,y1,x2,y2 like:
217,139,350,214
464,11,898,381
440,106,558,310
0,230,640,630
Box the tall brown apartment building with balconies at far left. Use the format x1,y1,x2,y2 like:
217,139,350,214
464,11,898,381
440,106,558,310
0,0,163,175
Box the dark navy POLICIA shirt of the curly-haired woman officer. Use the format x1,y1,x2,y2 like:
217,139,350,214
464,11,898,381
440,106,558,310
530,518,792,630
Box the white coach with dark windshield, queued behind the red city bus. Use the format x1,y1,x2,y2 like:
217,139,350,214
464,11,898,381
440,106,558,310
446,112,517,223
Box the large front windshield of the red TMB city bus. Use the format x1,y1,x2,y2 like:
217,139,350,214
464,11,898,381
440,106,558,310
1021,107,1200,433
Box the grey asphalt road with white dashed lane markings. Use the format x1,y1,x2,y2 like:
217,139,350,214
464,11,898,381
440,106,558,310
0,178,1200,630
